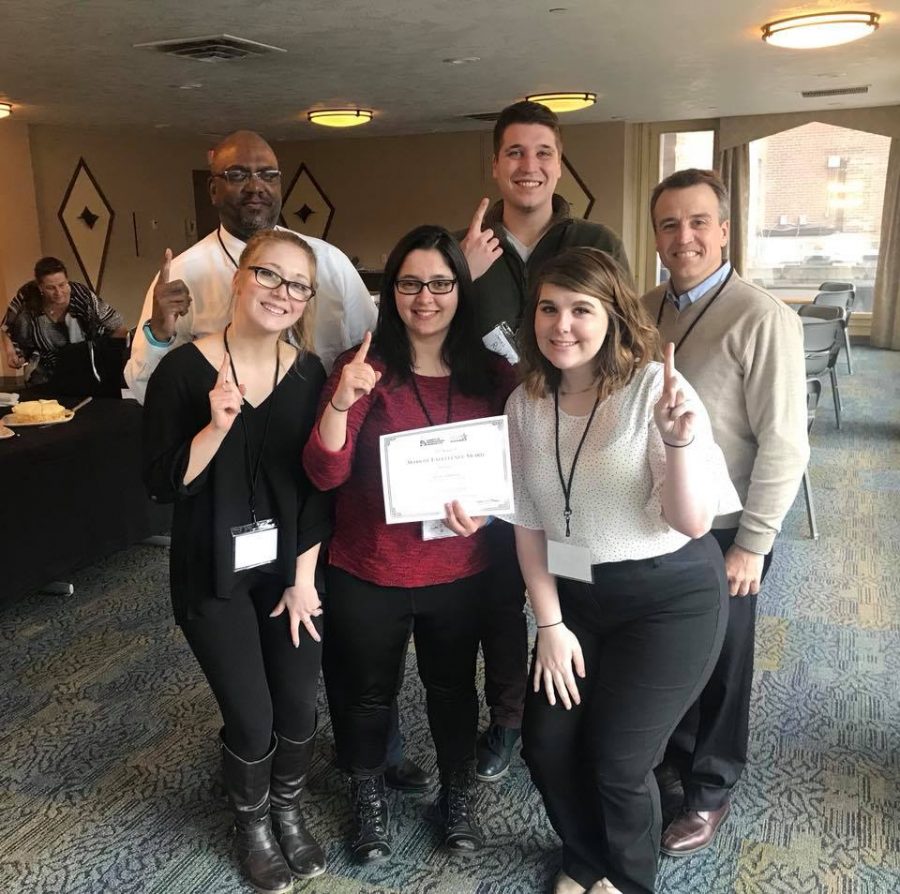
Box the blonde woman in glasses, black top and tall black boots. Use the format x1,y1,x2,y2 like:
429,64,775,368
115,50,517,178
144,230,330,892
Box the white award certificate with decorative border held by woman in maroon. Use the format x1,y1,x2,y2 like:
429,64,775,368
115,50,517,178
380,416,514,525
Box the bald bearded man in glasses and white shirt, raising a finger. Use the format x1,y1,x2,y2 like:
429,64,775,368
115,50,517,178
125,130,377,403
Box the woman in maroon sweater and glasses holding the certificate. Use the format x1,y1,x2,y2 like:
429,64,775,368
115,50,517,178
303,226,514,862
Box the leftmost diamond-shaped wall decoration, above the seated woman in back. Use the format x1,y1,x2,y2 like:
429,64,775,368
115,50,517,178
57,158,116,292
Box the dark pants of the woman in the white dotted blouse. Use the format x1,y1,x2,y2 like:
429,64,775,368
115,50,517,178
523,535,728,894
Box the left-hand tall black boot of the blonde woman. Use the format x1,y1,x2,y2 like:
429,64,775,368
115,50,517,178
222,742,294,894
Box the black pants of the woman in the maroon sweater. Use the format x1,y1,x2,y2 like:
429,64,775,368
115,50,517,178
324,566,484,776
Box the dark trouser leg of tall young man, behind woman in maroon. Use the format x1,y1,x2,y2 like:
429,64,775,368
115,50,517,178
481,521,528,729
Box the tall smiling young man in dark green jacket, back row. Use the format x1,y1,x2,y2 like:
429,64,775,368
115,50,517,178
460,101,629,782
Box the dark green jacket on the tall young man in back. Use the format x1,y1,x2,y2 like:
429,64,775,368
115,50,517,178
459,195,631,335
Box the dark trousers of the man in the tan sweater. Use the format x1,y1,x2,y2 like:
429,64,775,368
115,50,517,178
665,528,772,810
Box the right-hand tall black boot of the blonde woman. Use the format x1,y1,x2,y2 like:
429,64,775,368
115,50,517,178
270,733,325,878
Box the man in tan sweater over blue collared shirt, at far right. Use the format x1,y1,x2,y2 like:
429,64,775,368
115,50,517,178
643,168,809,857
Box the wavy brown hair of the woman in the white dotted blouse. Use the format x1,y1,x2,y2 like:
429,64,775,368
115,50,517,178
519,246,660,400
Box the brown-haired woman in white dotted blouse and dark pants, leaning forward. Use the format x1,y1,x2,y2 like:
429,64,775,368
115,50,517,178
507,248,740,894
